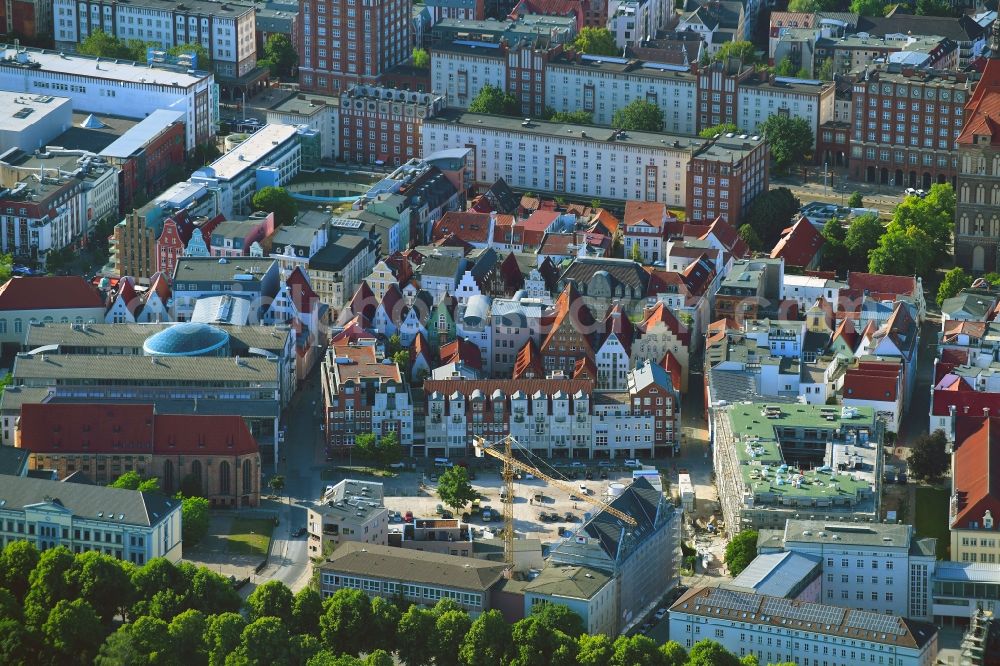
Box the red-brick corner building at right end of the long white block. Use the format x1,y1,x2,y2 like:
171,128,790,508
685,134,771,226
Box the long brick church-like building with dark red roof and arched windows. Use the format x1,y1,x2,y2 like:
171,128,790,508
14,403,260,507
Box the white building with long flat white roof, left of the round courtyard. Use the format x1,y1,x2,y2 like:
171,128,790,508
190,124,302,218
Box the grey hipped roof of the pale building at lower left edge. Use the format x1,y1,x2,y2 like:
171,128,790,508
0,476,180,527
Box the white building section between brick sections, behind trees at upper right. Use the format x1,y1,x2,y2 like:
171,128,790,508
736,81,835,148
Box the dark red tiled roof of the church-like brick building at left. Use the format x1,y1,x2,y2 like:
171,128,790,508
20,403,257,455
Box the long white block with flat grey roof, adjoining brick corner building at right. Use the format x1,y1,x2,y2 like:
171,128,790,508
423,110,705,206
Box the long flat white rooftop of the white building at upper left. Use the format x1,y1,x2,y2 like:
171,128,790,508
0,44,212,88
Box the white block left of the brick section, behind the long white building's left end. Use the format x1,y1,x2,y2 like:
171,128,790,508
432,43,507,109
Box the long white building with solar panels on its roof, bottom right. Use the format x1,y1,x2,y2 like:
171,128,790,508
670,587,938,666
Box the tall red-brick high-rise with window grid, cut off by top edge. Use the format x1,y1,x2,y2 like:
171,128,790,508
297,0,412,94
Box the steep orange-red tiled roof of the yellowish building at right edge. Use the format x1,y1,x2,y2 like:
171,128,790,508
951,414,1000,528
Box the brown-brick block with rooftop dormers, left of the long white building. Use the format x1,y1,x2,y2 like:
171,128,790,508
339,86,444,166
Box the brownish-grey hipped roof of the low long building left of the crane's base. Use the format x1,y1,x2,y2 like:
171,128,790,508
320,541,504,592
